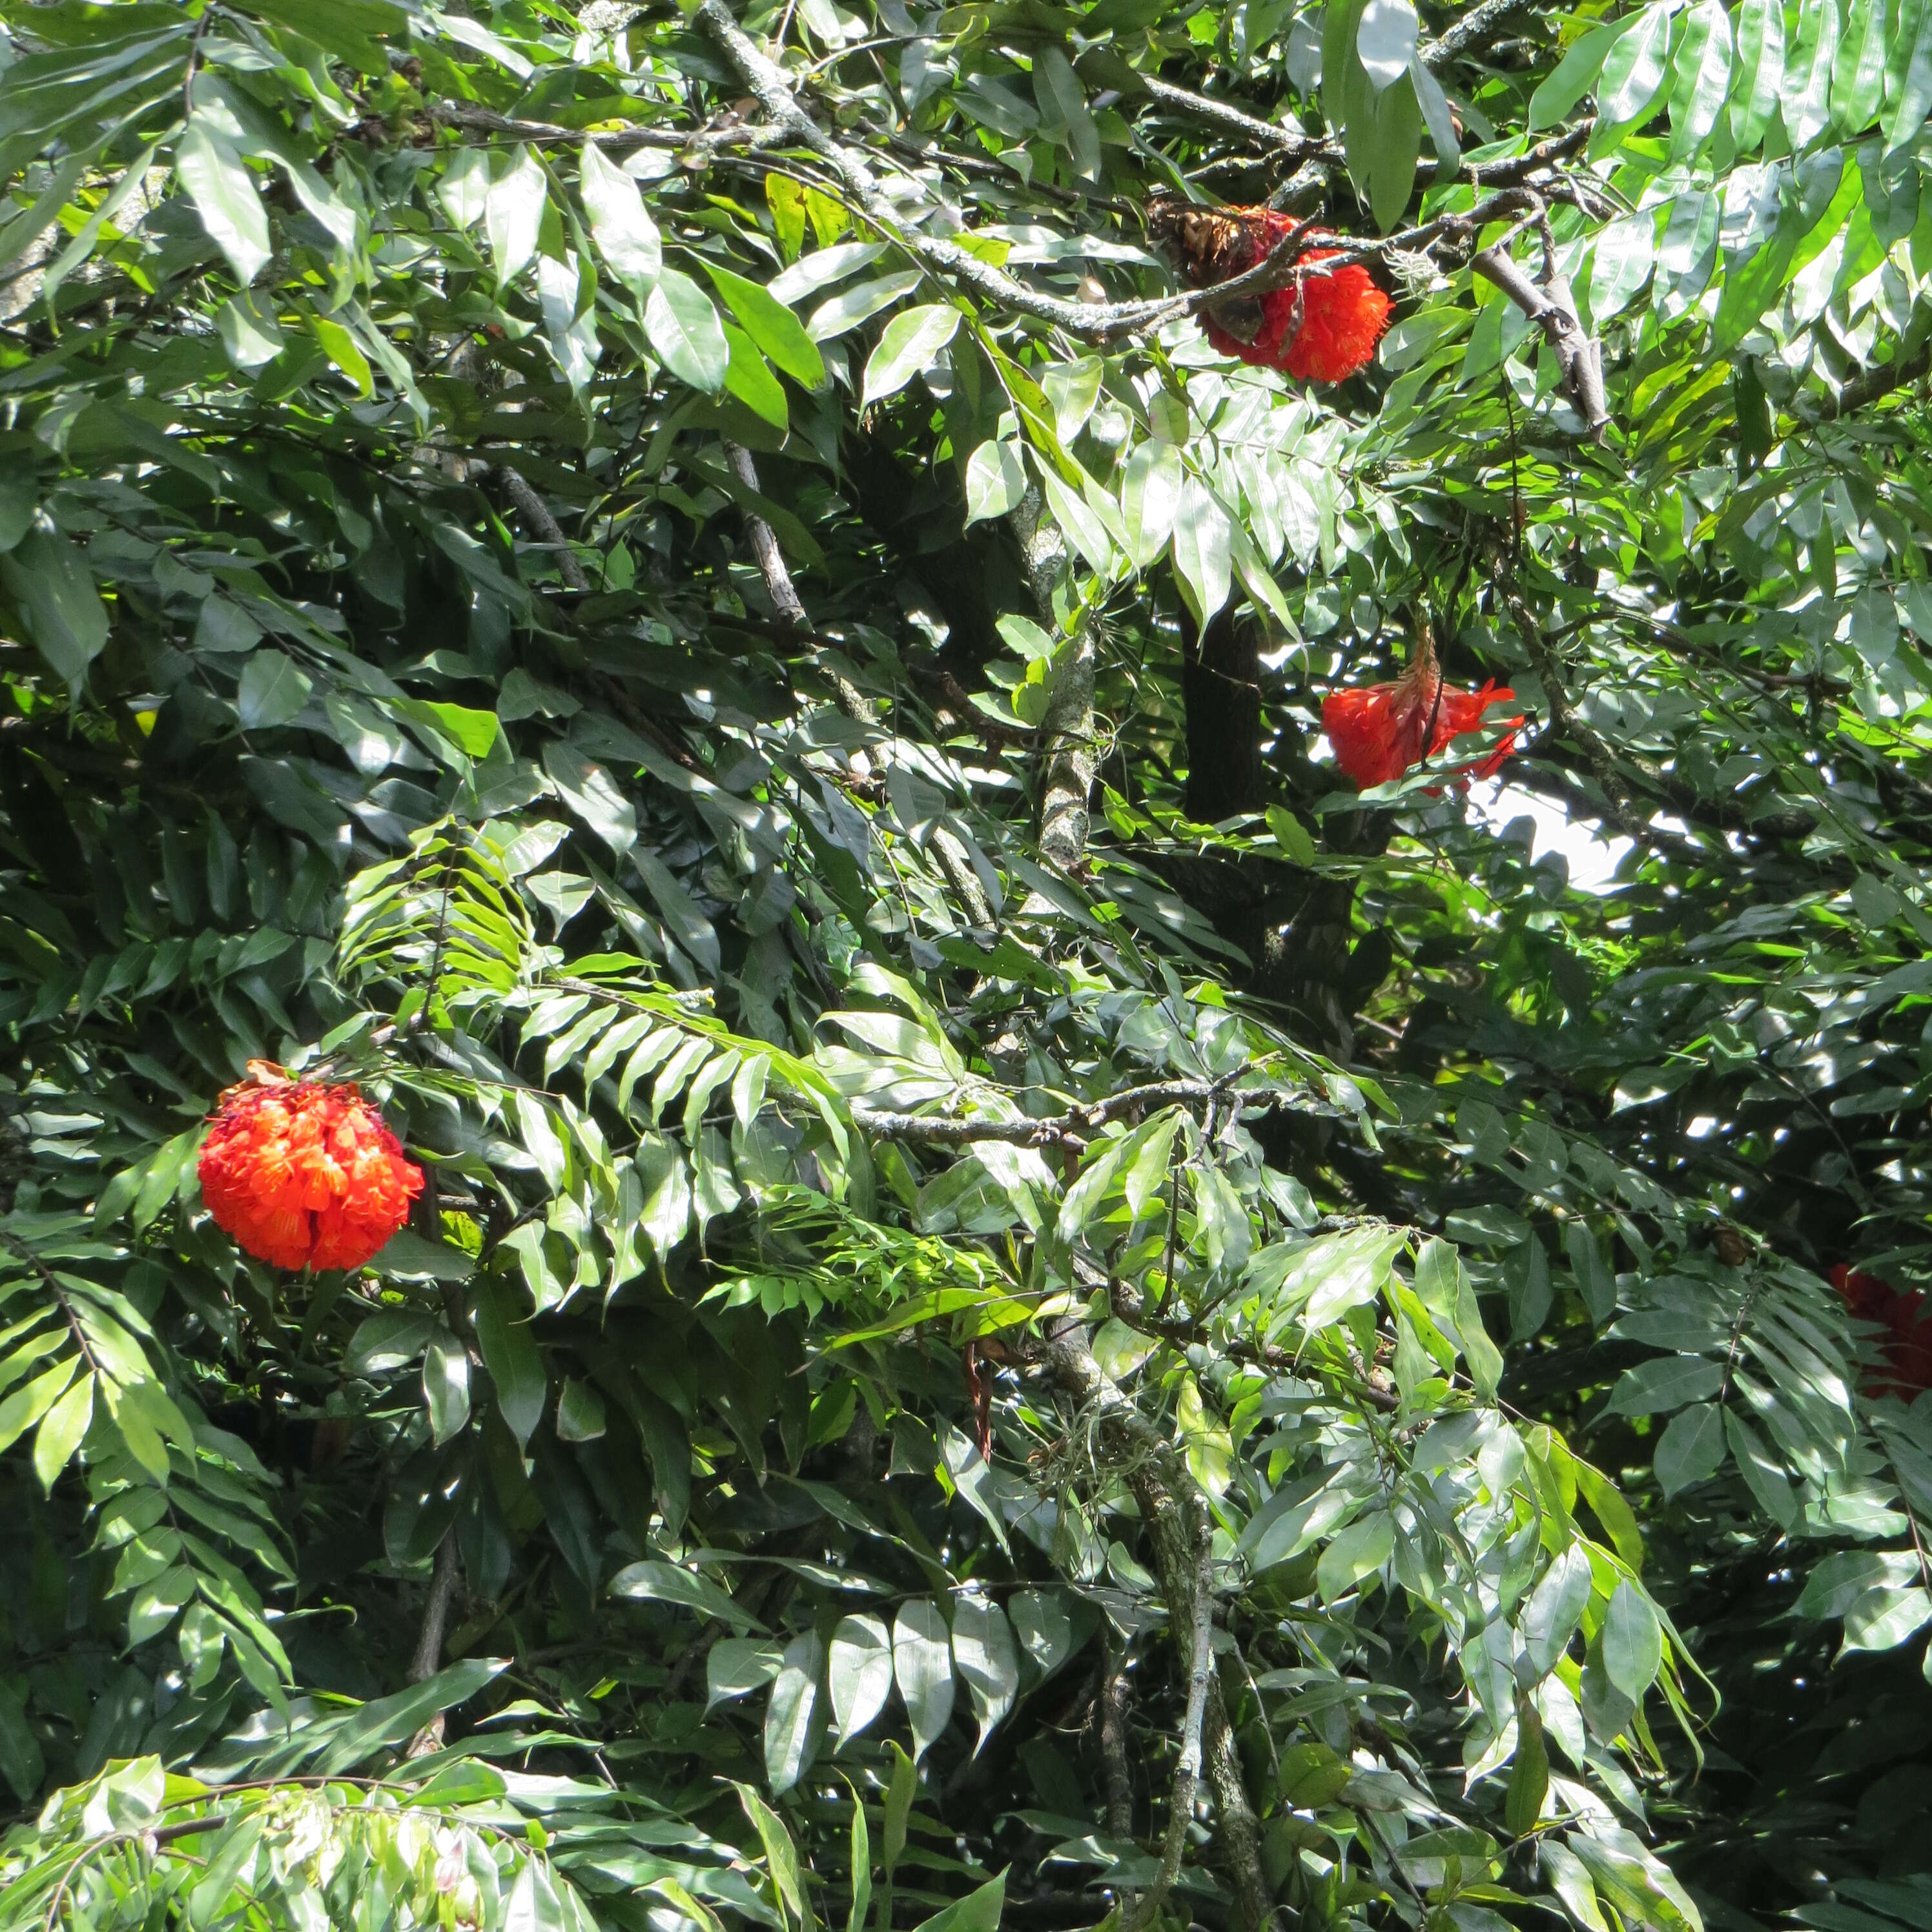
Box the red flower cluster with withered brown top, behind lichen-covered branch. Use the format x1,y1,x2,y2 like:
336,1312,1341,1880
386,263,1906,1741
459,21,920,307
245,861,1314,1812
1151,201,1393,382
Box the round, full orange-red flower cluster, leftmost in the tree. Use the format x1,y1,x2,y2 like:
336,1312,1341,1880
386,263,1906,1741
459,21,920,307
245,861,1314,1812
199,1065,423,1268
